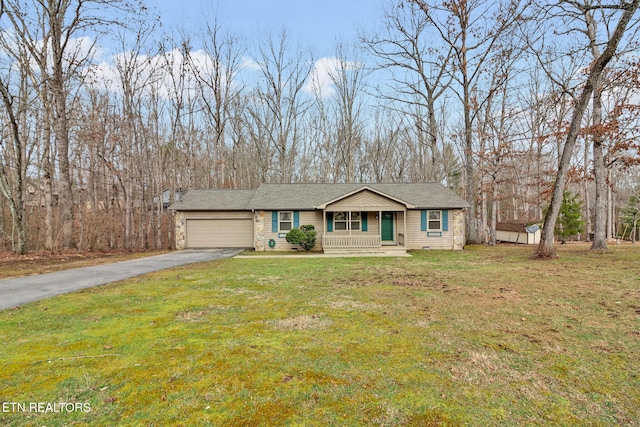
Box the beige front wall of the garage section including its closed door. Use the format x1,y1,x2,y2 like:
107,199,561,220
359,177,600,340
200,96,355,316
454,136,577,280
185,211,253,248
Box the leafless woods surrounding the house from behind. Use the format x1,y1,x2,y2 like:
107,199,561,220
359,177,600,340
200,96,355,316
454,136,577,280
0,0,640,256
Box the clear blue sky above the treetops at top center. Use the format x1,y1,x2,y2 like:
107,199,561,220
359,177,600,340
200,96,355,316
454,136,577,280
150,0,383,56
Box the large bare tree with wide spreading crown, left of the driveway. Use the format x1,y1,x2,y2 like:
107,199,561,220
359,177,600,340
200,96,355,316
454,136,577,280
4,0,138,248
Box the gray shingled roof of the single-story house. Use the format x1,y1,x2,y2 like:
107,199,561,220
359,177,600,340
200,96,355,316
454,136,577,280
170,183,469,211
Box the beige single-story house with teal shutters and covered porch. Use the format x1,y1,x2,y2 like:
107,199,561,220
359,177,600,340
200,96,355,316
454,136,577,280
170,183,469,252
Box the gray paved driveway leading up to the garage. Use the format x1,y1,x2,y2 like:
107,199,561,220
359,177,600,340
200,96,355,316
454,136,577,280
0,249,243,310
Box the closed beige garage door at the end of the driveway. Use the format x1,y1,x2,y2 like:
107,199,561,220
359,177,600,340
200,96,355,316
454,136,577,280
187,219,253,248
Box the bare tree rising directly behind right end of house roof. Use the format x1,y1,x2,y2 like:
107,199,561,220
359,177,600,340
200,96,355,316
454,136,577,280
361,0,454,181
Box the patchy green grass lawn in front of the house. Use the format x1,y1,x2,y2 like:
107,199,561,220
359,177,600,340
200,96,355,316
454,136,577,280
0,246,640,426
